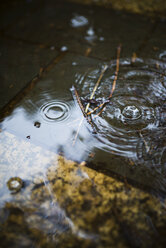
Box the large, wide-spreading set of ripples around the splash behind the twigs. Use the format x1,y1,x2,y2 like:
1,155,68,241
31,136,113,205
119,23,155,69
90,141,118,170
77,59,166,163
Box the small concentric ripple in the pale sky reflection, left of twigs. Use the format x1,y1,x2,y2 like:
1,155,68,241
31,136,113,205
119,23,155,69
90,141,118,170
40,101,70,122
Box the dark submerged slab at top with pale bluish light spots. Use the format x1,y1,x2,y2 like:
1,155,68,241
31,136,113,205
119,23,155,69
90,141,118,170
7,1,153,60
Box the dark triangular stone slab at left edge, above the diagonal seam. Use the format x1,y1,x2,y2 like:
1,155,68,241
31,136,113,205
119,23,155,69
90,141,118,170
0,38,58,109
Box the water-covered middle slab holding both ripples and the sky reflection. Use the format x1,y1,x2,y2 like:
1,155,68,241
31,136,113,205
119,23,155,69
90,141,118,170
2,54,166,194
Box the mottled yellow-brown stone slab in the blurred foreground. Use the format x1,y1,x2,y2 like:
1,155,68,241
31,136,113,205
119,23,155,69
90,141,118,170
0,133,166,247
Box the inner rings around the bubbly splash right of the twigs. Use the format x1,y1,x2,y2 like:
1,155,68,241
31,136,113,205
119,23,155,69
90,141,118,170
103,94,158,130
